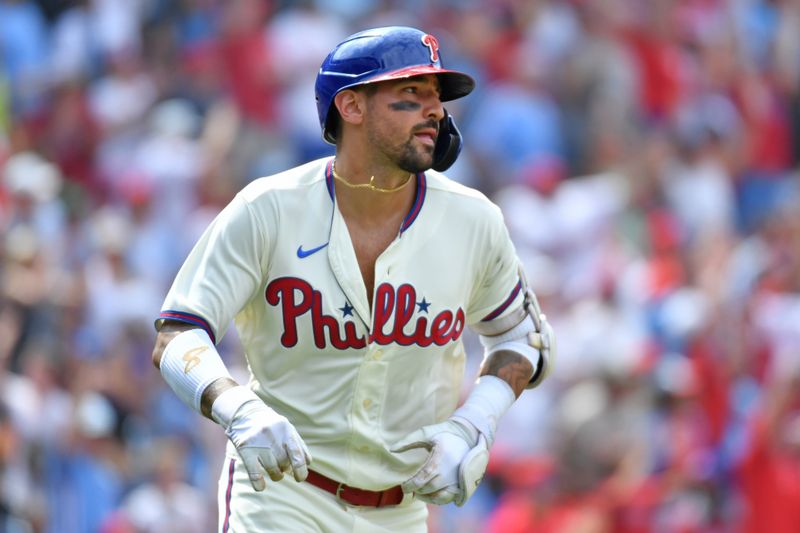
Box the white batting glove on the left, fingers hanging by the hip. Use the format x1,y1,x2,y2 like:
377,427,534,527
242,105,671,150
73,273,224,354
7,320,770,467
211,386,311,491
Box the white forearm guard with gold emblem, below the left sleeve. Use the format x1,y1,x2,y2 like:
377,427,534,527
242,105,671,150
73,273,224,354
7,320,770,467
159,329,231,413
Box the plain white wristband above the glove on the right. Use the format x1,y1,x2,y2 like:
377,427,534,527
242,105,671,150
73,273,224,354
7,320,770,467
453,376,517,448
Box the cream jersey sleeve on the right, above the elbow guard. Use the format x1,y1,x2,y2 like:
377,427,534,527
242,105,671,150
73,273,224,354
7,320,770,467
467,204,524,335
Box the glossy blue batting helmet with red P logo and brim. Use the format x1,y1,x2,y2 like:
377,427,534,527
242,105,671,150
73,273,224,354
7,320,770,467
315,26,475,144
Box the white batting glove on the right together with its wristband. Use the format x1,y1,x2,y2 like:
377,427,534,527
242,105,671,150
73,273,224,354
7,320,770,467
392,376,516,506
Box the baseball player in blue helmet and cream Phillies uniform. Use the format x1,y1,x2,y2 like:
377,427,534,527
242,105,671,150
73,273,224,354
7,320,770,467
153,27,554,533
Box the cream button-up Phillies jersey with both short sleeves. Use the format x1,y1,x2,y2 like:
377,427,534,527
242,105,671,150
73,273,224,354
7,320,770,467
161,158,523,490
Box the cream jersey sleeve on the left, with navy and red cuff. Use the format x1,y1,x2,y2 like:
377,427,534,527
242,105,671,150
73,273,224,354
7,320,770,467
156,194,269,343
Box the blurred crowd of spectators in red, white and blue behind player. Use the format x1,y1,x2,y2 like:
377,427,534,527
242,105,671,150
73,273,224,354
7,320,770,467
0,0,800,533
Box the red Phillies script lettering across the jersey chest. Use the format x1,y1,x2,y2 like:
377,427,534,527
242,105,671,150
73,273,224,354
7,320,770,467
265,277,465,350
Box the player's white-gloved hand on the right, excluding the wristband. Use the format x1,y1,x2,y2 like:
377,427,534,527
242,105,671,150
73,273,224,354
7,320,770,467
392,417,489,506
